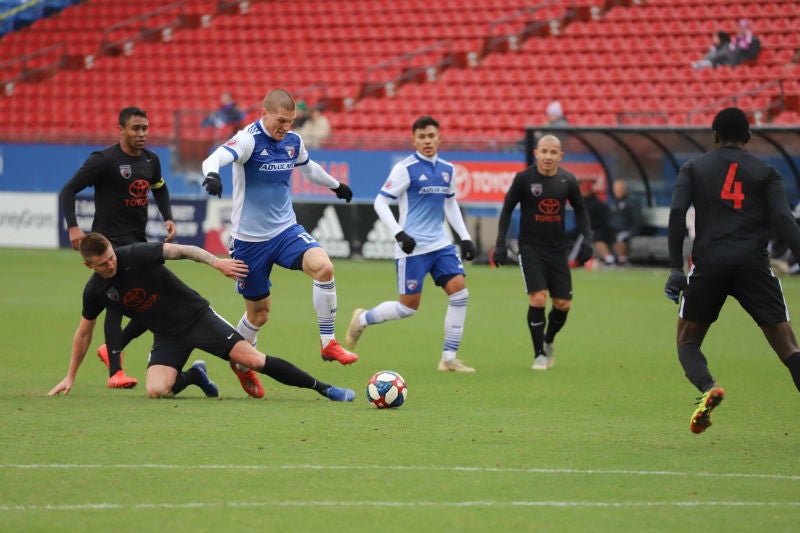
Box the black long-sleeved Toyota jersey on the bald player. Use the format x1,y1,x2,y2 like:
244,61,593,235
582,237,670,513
498,166,593,251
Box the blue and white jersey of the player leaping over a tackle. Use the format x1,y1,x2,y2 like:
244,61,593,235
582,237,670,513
223,121,309,242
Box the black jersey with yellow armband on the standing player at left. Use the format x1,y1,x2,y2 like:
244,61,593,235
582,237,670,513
61,144,172,246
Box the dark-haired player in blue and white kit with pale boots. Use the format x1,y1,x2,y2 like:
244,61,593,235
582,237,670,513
345,116,475,372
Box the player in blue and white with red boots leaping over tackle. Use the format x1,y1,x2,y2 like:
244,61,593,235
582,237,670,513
203,89,358,365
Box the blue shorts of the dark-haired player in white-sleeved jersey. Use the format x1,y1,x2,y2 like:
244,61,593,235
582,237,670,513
394,244,466,294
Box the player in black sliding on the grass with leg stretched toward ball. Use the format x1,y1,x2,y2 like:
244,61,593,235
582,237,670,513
48,233,355,402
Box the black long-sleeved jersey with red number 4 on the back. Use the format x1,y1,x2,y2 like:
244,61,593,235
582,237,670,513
669,146,800,267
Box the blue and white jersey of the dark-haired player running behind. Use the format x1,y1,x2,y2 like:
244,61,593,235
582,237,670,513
380,153,455,258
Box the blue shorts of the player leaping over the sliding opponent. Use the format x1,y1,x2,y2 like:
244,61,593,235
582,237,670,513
230,224,320,300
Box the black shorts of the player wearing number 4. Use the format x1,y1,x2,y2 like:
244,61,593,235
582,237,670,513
678,264,789,326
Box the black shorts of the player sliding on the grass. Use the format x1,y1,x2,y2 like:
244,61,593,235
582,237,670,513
147,307,244,372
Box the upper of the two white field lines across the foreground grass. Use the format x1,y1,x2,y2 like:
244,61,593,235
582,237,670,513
0,463,800,481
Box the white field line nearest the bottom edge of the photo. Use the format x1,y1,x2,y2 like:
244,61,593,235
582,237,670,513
0,500,800,512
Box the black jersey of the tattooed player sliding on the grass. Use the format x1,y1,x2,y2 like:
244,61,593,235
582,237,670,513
82,243,209,338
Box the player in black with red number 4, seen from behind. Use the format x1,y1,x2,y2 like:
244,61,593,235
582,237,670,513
665,107,800,433
